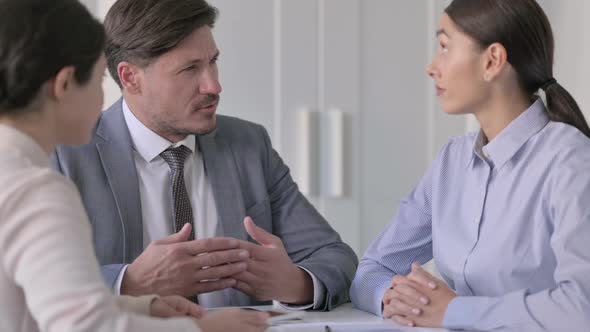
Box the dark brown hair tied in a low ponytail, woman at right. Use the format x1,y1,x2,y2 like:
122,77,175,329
445,0,590,137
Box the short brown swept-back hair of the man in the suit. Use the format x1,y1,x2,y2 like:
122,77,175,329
104,0,217,87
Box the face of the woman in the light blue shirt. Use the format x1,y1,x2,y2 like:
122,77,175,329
426,14,489,114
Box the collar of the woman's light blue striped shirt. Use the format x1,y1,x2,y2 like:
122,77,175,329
473,99,549,168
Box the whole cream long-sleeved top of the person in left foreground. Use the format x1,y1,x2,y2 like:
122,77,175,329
0,124,198,332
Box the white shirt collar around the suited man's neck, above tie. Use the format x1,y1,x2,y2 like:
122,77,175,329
123,100,196,162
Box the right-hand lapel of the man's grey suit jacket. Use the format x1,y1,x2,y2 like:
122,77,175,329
198,131,248,240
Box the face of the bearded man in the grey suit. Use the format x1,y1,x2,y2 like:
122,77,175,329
134,26,221,142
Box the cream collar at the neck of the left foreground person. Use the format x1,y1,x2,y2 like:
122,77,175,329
0,124,50,168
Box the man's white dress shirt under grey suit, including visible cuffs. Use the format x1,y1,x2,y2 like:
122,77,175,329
115,100,325,309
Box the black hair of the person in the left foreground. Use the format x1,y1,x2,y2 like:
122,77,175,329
0,0,105,115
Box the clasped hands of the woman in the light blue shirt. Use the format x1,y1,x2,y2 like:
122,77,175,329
382,263,457,327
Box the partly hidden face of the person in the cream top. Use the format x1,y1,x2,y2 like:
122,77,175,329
57,56,106,145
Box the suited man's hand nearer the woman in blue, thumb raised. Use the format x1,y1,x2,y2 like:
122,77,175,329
233,217,313,304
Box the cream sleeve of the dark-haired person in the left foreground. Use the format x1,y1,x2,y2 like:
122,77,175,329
0,172,199,332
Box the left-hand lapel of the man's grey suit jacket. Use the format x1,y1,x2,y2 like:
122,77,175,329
96,100,143,263
